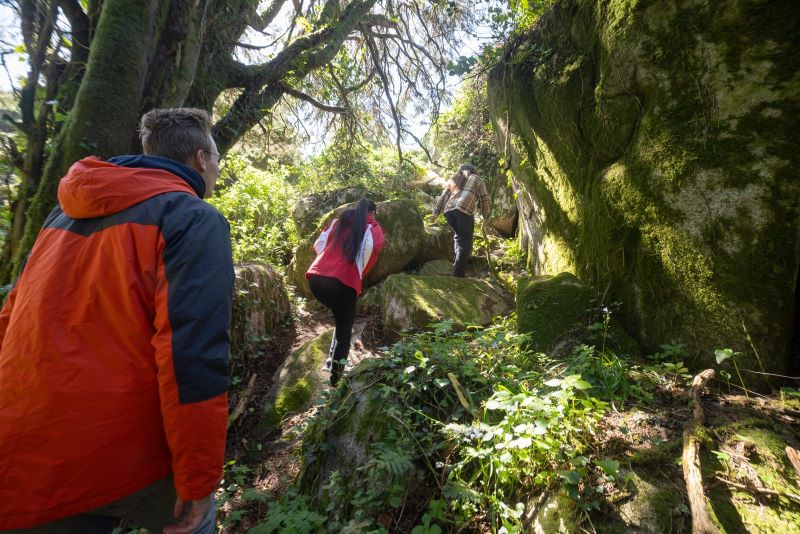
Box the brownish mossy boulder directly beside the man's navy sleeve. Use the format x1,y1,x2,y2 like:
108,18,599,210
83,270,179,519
231,263,290,354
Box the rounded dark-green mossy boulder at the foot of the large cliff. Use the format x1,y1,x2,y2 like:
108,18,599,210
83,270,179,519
517,273,596,352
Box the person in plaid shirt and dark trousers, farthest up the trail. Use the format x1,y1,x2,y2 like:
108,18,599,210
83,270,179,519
431,165,489,278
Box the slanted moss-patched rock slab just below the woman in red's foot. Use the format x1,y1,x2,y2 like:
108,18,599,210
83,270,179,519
262,330,333,428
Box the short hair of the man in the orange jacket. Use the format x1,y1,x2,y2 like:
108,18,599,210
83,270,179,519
139,108,211,163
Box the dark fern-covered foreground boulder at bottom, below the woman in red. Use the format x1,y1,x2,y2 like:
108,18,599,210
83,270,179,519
298,360,424,532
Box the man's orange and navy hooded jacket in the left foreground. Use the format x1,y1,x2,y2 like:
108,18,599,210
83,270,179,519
0,156,233,530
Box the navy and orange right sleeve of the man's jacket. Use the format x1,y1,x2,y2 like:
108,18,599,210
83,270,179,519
153,201,233,500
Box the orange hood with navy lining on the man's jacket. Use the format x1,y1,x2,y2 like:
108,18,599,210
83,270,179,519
58,155,205,219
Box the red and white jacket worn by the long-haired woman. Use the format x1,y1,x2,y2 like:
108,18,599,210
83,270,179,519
306,215,384,295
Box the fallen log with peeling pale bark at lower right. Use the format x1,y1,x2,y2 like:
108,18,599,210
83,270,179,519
682,369,719,534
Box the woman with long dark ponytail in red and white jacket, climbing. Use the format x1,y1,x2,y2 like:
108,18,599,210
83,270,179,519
306,198,384,387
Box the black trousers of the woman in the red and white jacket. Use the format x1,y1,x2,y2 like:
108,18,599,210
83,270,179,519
308,274,357,386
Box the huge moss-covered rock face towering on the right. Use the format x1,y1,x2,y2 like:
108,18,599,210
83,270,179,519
488,0,800,376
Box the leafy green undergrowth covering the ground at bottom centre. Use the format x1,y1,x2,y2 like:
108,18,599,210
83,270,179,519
251,316,658,534
